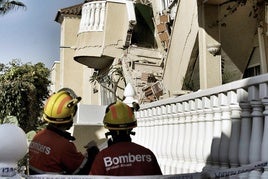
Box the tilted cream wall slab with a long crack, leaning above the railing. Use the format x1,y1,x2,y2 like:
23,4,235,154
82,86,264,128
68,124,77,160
163,1,199,95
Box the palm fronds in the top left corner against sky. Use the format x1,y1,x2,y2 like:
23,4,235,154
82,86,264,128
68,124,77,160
0,0,26,15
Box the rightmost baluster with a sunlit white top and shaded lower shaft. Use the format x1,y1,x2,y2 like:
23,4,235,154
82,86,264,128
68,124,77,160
228,91,241,168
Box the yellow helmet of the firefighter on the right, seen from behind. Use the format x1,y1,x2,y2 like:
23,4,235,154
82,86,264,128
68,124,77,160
103,101,137,130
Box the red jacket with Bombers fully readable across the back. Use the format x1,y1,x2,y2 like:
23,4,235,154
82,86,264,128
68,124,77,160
89,142,162,176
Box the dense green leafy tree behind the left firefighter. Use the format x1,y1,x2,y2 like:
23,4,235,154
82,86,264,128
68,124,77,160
0,60,50,132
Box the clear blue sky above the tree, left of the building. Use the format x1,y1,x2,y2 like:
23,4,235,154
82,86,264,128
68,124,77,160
0,0,84,68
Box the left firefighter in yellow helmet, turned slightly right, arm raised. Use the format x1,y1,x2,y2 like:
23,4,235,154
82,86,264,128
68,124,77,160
29,88,99,175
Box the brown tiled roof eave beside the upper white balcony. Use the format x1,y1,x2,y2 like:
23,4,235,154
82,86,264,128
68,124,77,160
55,3,83,23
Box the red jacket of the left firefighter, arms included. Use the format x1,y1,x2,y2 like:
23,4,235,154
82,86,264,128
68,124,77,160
29,129,87,174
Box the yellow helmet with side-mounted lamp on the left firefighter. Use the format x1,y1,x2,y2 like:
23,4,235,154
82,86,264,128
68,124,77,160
43,90,81,124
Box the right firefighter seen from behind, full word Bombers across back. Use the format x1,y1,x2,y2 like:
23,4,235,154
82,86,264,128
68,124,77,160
89,101,162,176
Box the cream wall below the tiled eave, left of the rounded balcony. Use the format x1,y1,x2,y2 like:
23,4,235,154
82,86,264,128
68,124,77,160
60,17,99,104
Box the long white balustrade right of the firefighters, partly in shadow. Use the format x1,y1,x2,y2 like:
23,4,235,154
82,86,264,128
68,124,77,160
134,74,268,178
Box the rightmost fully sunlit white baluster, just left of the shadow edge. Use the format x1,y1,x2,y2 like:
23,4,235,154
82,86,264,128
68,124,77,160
195,99,207,172
